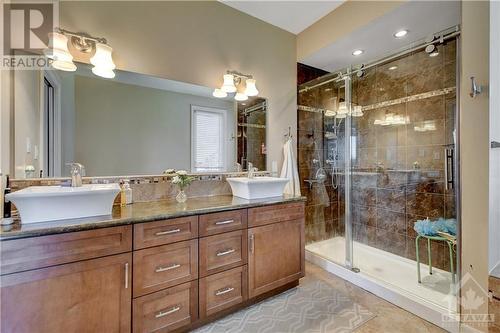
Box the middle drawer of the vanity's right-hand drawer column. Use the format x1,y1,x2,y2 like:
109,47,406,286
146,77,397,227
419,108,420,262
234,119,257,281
200,229,247,277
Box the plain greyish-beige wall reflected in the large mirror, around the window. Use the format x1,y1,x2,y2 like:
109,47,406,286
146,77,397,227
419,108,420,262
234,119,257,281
74,76,236,176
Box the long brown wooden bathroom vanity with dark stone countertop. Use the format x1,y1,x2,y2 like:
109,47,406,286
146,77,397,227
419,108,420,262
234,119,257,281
0,196,305,332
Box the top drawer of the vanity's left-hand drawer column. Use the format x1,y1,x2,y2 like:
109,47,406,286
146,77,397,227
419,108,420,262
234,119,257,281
134,216,198,249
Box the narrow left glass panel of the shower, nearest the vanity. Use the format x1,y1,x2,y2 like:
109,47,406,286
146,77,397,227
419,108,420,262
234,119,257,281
298,76,347,265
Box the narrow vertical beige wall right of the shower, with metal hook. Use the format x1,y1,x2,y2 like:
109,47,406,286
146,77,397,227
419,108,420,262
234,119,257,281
460,1,489,330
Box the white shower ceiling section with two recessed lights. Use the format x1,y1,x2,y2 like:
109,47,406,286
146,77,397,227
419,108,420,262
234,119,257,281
300,1,460,72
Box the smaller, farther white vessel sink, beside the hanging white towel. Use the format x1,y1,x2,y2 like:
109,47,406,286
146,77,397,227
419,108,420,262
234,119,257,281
226,177,289,199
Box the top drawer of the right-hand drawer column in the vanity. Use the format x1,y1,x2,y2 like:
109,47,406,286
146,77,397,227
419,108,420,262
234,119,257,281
199,209,247,236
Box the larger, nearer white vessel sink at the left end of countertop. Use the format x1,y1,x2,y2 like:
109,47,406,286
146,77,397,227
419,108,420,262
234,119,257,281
5,184,120,223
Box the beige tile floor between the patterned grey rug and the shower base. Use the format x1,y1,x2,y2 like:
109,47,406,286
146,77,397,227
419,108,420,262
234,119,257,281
306,263,445,333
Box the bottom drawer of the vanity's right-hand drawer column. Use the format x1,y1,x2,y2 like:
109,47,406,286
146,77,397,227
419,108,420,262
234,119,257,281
200,265,248,318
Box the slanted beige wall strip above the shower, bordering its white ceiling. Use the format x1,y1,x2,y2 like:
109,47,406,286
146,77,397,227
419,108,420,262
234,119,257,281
297,0,405,62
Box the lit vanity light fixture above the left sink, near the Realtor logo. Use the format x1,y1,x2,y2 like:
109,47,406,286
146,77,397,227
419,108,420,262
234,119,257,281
44,28,116,78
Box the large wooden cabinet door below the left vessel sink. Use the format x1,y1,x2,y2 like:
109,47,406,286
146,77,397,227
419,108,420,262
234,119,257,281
0,253,132,333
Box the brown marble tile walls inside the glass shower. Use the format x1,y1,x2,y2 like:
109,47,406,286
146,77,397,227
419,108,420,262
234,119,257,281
298,41,456,269
